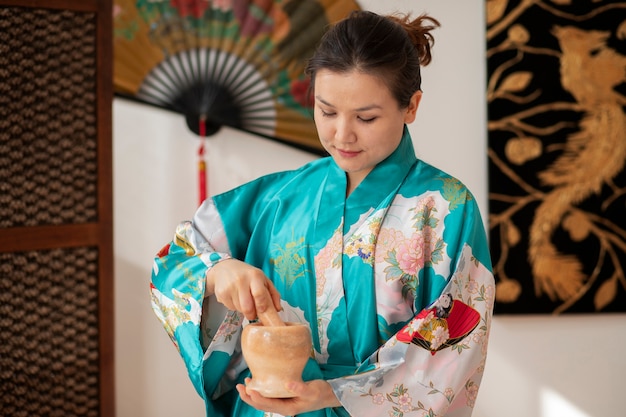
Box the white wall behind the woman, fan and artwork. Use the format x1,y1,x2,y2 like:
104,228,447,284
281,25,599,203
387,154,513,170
109,0,626,417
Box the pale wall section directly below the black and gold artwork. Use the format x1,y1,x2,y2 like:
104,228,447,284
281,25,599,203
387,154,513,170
474,314,626,417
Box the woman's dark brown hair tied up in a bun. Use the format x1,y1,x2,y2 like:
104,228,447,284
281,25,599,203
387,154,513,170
305,11,439,108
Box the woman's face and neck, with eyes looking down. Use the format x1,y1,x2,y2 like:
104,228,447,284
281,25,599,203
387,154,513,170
314,69,421,191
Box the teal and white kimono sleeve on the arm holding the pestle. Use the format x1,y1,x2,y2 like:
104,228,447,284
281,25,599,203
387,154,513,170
150,169,290,406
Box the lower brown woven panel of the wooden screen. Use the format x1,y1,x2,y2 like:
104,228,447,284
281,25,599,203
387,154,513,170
0,248,99,417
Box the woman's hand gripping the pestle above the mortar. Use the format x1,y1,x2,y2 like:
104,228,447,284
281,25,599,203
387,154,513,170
206,259,281,320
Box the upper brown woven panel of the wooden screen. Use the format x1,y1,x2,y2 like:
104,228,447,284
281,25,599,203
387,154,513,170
0,7,97,228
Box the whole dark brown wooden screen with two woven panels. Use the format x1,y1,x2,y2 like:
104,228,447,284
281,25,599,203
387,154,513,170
0,0,115,417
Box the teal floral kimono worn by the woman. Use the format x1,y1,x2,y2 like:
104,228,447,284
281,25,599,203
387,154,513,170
151,128,495,417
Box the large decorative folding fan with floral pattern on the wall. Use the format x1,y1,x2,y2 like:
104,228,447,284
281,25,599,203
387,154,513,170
114,0,359,153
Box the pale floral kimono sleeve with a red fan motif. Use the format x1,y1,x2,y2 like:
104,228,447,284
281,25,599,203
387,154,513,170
328,193,495,417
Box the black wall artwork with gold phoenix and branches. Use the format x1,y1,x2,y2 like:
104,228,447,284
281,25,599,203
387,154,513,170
486,0,626,314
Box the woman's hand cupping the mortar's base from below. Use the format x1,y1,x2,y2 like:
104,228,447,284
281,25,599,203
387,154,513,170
237,378,341,416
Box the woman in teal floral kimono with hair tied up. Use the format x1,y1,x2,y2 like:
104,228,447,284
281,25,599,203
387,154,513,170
152,11,494,417
